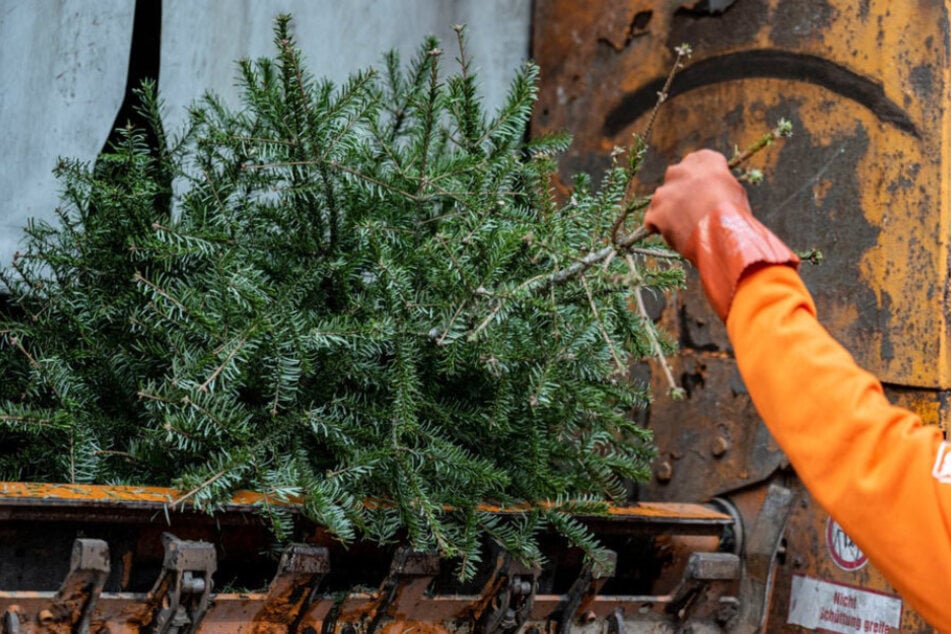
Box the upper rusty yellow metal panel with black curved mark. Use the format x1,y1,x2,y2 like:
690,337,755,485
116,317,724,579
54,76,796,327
533,0,951,389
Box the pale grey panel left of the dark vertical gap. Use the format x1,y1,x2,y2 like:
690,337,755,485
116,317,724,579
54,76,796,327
0,0,135,266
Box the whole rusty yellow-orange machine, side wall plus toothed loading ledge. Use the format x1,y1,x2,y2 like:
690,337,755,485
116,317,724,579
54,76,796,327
0,0,951,634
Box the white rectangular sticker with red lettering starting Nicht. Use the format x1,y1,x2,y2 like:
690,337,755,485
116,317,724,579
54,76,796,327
787,575,902,634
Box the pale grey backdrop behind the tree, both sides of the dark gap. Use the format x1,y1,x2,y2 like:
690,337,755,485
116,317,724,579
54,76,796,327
0,0,531,265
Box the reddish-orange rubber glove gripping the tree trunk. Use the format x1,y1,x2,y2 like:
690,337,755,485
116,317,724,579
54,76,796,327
644,150,799,321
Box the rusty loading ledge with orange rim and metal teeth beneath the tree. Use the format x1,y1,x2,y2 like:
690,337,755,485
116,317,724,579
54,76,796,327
0,483,748,634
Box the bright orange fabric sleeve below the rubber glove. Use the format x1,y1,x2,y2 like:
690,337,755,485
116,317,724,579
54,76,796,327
727,266,951,632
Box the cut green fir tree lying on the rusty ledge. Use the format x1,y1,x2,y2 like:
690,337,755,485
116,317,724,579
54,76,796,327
0,18,680,574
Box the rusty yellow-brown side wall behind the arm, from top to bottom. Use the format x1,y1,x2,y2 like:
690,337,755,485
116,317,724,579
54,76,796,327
532,0,951,632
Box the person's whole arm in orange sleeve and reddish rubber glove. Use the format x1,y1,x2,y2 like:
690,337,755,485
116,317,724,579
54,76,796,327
645,151,951,632
